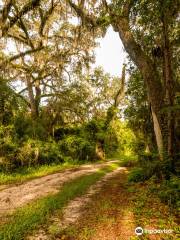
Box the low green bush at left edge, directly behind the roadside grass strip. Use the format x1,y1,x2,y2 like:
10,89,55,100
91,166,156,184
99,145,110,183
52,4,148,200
0,139,66,172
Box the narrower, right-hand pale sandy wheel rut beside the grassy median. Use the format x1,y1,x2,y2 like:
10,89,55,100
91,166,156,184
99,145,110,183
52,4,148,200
26,167,126,240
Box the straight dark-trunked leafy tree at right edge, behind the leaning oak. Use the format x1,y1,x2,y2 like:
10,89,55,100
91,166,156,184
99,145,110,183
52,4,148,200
131,1,178,169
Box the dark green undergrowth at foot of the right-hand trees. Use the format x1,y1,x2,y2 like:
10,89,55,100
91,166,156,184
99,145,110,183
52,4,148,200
128,154,180,209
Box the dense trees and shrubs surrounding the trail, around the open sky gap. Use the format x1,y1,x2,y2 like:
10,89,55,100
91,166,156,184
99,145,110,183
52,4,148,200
0,0,180,208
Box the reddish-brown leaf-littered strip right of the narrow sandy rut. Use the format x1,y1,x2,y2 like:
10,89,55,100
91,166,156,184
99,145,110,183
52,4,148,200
69,168,135,240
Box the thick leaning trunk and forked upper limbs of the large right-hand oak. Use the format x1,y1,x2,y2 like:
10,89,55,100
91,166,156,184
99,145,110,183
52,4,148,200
65,0,176,162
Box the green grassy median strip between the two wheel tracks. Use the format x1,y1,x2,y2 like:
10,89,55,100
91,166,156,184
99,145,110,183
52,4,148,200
0,164,118,240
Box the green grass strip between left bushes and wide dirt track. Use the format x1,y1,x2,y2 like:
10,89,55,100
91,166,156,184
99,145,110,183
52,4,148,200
0,163,79,185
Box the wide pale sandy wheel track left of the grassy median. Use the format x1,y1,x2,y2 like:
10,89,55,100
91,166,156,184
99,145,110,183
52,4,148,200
0,161,116,218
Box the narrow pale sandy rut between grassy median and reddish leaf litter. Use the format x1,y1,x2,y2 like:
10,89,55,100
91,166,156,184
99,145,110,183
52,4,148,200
27,167,126,240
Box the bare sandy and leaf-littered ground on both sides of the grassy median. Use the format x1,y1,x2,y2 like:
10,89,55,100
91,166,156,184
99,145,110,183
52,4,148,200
0,161,179,240
